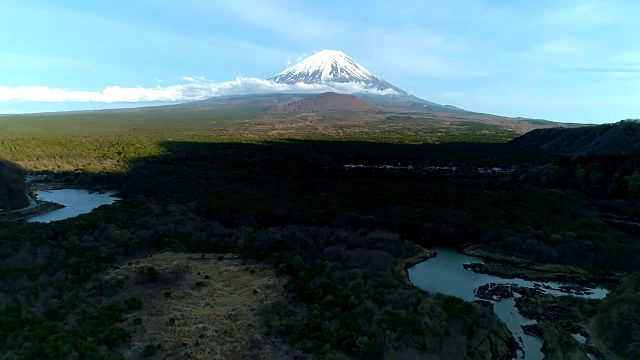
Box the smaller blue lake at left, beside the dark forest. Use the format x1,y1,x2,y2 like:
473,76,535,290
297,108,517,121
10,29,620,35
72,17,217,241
26,189,119,223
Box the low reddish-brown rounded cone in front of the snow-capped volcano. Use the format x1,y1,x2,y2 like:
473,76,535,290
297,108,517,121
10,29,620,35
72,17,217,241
279,92,377,113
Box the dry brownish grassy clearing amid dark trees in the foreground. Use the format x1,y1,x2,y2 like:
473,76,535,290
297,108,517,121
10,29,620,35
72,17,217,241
108,253,293,359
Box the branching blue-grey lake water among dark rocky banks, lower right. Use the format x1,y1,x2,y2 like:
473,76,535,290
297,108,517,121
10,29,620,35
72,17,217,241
408,247,607,360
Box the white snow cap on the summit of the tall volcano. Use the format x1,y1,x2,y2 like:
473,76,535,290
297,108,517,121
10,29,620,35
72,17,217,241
269,50,406,94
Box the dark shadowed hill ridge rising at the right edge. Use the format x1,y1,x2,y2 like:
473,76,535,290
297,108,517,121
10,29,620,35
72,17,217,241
511,120,640,154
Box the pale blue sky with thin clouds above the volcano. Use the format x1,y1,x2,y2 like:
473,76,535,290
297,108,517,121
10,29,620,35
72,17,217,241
0,0,640,123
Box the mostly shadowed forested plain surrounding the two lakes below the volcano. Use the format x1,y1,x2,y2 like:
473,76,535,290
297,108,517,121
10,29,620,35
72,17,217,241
0,113,640,359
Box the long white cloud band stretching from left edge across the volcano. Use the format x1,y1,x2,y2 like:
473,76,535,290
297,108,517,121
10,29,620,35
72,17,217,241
0,76,396,103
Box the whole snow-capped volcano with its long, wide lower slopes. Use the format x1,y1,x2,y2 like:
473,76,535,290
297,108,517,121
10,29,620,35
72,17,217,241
38,50,557,132
